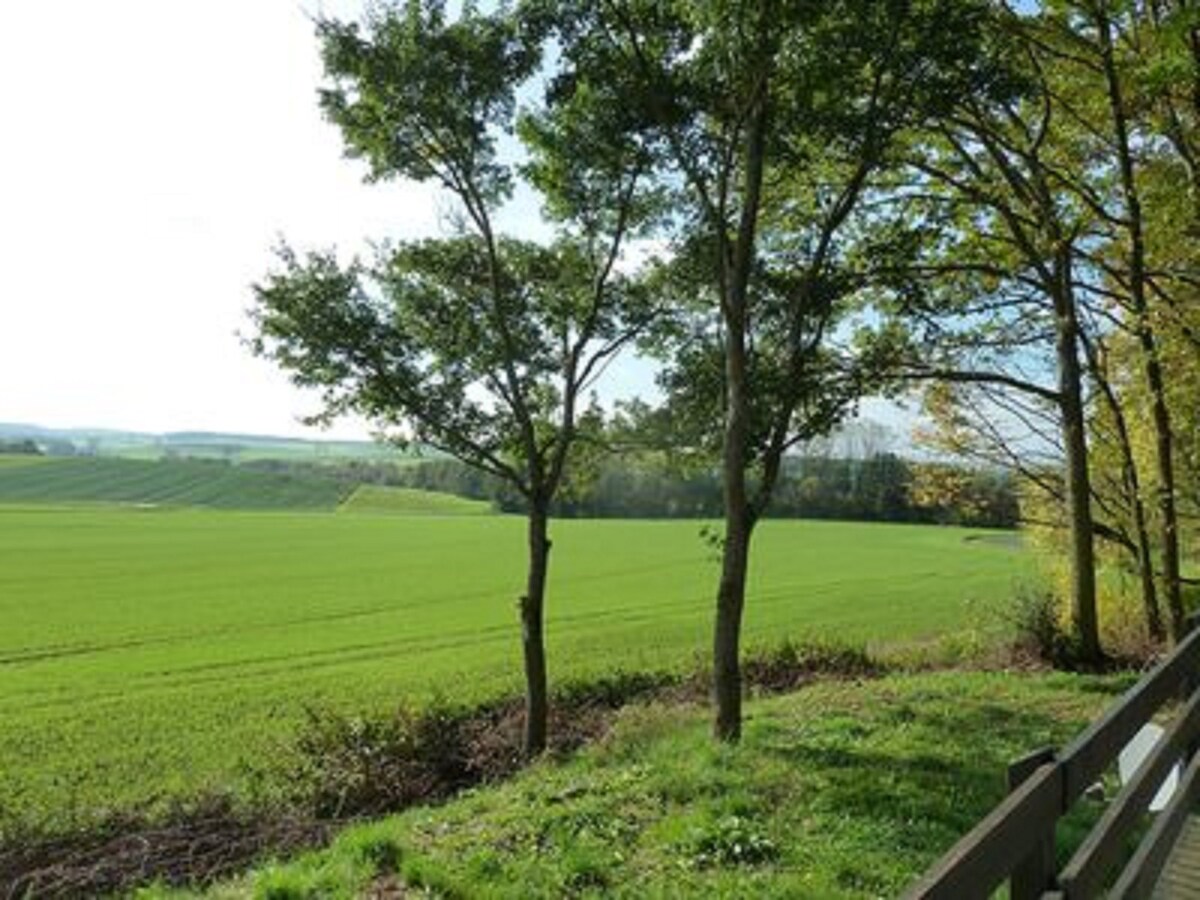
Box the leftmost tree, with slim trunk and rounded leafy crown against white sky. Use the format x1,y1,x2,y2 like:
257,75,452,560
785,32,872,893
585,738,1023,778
253,0,648,755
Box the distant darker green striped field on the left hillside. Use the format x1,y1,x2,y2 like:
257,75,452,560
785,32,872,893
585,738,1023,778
0,457,348,510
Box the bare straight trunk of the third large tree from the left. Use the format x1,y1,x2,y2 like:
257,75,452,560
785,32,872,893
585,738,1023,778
1054,248,1100,662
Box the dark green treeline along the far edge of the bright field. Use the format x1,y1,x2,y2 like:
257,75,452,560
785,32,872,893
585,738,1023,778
393,452,1018,528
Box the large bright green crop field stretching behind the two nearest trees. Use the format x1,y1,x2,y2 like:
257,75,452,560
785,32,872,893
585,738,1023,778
0,508,1026,840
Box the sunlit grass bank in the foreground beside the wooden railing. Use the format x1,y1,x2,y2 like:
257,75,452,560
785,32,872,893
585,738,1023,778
145,672,1127,900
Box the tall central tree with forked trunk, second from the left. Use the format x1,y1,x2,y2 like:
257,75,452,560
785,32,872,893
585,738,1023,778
557,0,993,740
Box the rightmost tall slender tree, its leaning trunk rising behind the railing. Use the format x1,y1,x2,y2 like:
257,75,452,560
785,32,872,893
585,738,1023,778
993,0,1194,637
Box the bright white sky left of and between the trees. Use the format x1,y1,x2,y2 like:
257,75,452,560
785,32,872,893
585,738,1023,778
0,0,894,446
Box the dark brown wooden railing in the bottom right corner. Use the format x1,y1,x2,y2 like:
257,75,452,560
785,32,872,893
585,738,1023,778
905,618,1200,900
